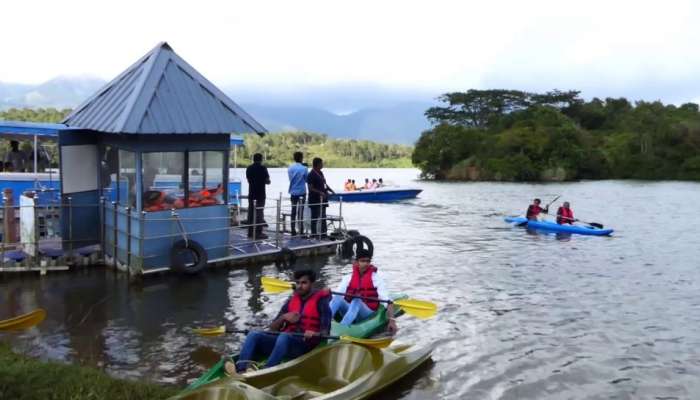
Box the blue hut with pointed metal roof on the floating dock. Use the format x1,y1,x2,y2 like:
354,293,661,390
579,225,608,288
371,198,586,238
58,43,266,273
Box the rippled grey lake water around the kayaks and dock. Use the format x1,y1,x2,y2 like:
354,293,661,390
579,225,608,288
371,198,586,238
0,170,700,399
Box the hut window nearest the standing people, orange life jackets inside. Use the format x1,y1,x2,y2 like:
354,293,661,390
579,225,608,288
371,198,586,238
187,151,225,207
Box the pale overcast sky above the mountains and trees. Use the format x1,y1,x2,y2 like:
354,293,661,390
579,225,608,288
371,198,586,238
0,0,700,102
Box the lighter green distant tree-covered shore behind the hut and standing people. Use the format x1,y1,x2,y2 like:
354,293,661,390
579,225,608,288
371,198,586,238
0,108,413,168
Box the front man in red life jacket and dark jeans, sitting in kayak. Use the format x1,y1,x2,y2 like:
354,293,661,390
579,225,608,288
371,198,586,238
224,270,331,374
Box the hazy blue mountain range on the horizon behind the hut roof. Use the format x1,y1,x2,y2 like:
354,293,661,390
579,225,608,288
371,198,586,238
0,76,435,144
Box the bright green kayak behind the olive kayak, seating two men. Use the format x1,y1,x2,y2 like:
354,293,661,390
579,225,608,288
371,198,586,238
185,295,406,392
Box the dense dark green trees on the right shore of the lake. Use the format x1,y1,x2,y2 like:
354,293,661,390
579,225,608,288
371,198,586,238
412,90,700,182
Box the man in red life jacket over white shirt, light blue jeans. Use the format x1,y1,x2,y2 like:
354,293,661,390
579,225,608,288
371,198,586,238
331,249,398,335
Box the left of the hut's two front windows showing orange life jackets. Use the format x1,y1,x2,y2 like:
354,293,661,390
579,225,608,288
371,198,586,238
142,152,185,211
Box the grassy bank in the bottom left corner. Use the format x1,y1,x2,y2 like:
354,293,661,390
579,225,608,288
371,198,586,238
0,343,178,400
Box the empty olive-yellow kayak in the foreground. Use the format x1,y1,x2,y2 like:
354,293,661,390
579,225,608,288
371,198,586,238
171,342,432,400
